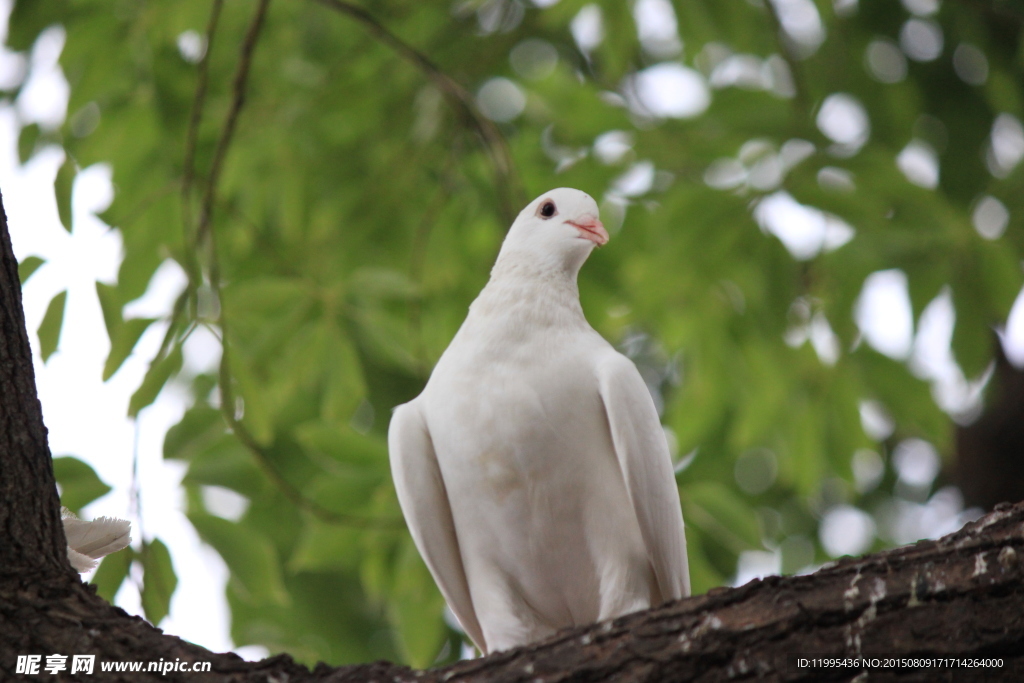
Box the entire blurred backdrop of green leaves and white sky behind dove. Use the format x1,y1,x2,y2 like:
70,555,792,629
0,0,1024,667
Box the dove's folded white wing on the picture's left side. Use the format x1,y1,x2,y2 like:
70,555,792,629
388,401,487,653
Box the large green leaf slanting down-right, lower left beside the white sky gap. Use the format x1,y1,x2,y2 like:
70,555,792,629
188,513,291,605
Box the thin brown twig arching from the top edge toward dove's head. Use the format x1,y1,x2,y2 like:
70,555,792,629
314,0,524,224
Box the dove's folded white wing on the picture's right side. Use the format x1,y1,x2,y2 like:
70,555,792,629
597,353,690,601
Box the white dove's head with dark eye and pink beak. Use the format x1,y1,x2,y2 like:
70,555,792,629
502,187,608,275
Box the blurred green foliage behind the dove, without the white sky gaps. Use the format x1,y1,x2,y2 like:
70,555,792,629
14,0,1024,666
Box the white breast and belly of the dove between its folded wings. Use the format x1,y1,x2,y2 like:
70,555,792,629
424,331,652,642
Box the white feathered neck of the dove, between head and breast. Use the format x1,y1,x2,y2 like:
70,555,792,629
470,257,589,334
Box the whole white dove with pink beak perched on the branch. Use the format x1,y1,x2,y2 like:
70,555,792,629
388,188,690,654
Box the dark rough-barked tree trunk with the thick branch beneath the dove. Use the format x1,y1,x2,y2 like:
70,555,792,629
0,187,1024,683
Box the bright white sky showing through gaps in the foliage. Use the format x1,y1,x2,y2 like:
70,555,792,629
0,0,1024,657
